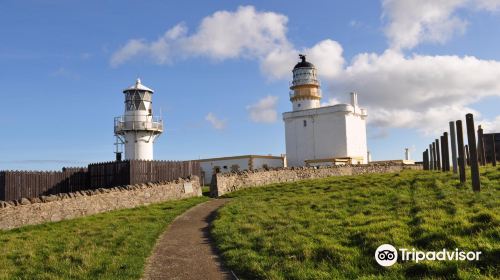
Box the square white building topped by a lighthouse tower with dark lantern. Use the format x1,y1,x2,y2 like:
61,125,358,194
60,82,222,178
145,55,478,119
283,55,368,166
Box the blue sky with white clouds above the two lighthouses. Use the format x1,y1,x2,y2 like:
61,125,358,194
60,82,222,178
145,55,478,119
0,0,500,170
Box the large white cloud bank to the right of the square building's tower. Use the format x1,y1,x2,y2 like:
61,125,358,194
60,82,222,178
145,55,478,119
332,50,500,133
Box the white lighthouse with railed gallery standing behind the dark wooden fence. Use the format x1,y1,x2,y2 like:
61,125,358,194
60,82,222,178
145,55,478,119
115,79,163,160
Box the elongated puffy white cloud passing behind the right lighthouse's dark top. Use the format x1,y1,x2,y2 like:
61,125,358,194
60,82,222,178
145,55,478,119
110,6,344,79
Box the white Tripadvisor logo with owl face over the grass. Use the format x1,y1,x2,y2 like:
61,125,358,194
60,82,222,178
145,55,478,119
375,244,482,266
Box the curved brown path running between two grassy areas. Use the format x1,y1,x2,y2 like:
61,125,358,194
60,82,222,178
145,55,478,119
143,199,236,280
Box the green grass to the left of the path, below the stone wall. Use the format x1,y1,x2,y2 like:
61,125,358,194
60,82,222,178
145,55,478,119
0,197,208,279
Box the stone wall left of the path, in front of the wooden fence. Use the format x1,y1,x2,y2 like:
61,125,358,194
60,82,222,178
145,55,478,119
0,176,202,229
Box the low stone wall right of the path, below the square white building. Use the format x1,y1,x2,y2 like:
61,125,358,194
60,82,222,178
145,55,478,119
210,164,422,197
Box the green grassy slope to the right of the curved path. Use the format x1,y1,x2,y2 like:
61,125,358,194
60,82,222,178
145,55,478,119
211,167,500,279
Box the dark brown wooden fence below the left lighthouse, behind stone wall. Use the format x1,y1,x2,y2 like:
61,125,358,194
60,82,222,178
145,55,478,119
0,160,201,201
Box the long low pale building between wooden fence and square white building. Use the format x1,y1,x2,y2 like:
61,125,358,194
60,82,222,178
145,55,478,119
199,155,285,184
